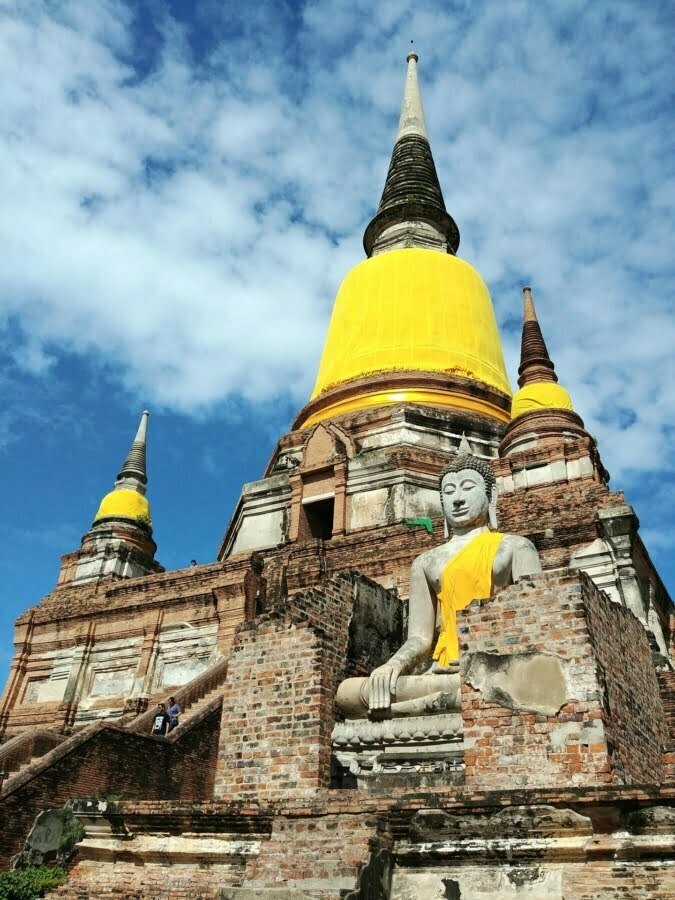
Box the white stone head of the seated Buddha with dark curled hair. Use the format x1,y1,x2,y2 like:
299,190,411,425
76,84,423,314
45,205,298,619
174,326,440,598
440,453,497,531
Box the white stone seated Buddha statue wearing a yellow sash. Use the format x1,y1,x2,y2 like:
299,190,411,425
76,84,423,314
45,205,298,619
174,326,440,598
336,439,541,719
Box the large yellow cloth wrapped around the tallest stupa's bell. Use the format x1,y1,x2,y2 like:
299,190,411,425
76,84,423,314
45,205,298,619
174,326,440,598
312,247,511,399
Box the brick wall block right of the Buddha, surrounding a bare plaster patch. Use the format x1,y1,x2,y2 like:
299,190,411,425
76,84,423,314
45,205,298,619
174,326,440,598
458,571,665,788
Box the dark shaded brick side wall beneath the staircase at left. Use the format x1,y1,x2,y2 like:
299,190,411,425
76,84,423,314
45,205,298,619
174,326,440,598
0,707,220,867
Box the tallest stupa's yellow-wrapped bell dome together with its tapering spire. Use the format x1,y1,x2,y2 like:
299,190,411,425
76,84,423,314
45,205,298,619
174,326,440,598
296,52,511,428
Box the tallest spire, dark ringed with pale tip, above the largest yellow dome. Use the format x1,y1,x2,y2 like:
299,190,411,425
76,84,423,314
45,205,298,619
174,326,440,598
363,51,459,256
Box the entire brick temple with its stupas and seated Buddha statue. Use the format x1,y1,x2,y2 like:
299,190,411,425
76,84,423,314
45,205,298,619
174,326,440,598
0,53,675,900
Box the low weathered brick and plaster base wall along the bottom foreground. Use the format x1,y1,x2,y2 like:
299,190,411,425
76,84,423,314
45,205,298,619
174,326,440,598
46,786,675,900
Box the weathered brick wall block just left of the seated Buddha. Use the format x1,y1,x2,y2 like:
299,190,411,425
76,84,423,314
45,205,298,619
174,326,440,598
215,573,400,800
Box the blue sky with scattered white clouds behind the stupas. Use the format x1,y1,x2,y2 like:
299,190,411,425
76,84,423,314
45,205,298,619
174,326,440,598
0,0,675,684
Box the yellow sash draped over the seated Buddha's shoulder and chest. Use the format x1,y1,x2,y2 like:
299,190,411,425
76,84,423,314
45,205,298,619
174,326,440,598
434,531,504,666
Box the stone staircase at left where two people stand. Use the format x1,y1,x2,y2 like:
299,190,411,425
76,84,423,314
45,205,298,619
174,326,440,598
0,659,227,794
